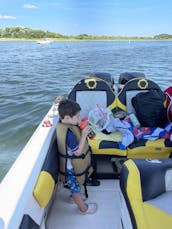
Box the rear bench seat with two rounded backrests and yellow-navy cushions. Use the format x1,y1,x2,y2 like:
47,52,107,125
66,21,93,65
68,77,172,158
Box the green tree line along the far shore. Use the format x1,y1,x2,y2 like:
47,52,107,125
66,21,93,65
0,27,172,40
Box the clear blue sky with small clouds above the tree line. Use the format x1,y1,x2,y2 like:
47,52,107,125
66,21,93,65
0,0,172,37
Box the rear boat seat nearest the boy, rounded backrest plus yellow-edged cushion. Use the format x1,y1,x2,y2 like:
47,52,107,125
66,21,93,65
68,77,126,156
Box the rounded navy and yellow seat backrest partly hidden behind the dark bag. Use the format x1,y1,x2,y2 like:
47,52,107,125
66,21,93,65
116,78,161,113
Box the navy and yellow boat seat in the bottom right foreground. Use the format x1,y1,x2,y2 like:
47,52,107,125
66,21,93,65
120,159,172,229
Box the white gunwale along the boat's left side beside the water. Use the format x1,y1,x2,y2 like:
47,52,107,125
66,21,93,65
0,106,58,229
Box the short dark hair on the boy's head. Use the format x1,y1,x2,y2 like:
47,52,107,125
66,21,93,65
58,99,81,119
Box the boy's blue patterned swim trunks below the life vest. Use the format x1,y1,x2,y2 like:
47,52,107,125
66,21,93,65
66,169,81,194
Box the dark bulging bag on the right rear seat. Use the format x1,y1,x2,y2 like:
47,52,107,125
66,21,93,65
132,90,168,127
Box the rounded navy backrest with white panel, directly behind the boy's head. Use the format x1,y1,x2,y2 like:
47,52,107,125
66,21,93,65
68,78,115,118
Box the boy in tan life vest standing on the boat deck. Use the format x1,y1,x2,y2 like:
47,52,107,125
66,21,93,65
57,99,97,214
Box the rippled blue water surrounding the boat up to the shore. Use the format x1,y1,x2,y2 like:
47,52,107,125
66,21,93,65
0,41,172,180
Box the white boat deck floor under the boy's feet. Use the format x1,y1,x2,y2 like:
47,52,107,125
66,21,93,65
46,180,122,229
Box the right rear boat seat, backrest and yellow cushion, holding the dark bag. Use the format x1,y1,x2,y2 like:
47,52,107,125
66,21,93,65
116,78,172,158
